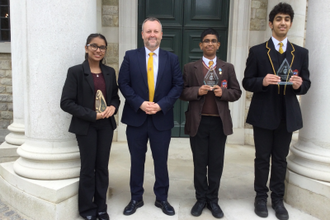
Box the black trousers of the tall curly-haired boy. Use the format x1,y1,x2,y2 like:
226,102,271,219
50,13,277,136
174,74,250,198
253,122,292,202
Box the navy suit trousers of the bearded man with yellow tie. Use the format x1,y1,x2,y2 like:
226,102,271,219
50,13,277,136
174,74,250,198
126,116,171,201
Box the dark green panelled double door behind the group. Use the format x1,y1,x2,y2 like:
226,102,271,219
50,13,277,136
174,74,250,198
138,0,229,137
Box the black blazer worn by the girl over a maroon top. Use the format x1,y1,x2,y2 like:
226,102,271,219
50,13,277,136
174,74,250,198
61,60,120,135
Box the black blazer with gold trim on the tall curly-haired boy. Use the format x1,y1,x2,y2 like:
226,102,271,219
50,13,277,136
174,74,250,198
243,39,311,132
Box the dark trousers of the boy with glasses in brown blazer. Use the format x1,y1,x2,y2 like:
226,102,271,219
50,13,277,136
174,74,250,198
190,116,227,202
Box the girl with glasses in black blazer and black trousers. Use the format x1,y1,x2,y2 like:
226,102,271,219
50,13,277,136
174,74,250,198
61,34,120,220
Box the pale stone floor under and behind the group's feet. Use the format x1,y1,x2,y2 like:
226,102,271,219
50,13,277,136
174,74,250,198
104,138,317,220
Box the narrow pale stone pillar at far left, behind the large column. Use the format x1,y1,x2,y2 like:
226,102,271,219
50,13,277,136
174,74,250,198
0,0,27,162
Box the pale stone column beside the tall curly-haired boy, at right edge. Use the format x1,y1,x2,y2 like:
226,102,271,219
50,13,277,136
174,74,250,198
286,1,330,219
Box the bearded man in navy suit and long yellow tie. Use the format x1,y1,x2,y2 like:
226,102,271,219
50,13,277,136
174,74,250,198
118,18,183,215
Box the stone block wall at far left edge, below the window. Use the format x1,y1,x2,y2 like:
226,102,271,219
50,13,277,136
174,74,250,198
0,53,13,129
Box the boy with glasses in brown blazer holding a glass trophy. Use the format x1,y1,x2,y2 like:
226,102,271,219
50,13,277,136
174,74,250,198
180,28,242,218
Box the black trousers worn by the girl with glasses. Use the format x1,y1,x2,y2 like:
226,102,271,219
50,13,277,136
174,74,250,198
76,119,113,216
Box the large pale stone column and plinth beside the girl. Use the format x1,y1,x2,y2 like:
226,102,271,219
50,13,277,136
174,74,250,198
0,0,97,220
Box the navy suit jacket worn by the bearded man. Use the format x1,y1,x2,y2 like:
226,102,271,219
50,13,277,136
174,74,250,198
118,47,183,131
